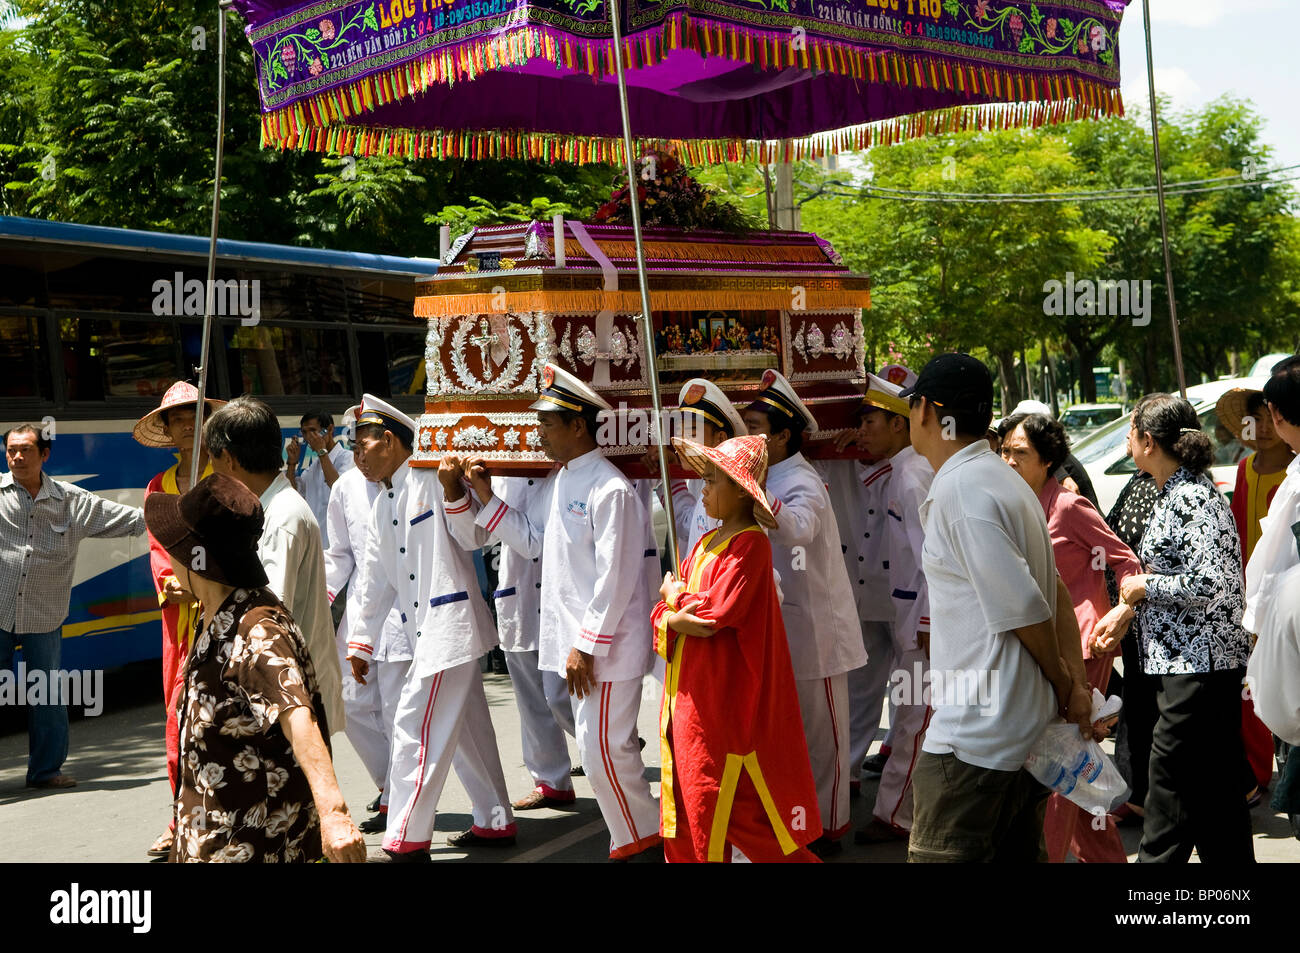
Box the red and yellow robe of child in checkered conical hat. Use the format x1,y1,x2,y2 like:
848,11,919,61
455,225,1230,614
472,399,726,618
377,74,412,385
651,527,822,862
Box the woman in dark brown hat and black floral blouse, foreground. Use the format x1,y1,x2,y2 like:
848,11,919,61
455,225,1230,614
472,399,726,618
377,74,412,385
144,473,365,862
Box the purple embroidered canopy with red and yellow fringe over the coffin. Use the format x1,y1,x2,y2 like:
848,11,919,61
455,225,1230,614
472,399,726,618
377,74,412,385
234,0,1127,161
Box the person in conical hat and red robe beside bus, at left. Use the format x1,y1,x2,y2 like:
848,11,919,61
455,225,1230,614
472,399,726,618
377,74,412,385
131,381,225,857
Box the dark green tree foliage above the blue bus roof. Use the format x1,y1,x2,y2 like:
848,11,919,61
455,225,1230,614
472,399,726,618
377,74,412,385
0,0,612,255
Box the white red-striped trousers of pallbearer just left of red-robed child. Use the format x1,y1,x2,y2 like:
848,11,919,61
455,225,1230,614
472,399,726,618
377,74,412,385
571,679,659,857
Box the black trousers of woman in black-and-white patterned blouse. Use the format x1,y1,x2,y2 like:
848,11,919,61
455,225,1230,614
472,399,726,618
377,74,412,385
1138,668,1255,863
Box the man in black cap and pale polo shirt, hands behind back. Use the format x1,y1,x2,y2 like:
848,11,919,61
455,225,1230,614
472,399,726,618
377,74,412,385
901,354,1092,863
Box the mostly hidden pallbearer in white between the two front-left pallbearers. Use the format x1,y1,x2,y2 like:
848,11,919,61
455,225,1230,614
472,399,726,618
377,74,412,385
491,476,575,811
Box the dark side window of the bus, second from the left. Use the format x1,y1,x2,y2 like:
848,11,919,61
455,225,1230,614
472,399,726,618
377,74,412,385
59,317,181,400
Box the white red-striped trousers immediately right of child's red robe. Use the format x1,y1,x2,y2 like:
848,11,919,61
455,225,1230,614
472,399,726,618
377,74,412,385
794,672,849,839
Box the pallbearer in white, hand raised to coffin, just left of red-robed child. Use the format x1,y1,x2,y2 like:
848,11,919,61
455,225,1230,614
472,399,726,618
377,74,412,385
447,364,660,859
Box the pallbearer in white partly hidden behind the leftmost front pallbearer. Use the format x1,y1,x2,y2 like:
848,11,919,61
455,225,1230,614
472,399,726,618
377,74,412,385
325,404,412,833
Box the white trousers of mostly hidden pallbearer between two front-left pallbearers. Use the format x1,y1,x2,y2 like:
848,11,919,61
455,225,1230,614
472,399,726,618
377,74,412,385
506,651,575,796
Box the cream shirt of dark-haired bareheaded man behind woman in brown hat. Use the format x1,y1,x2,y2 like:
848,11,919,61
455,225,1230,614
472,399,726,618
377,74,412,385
257,473,345,735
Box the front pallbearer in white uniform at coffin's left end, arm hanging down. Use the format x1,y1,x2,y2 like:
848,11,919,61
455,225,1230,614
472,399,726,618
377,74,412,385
347,394,515,861
